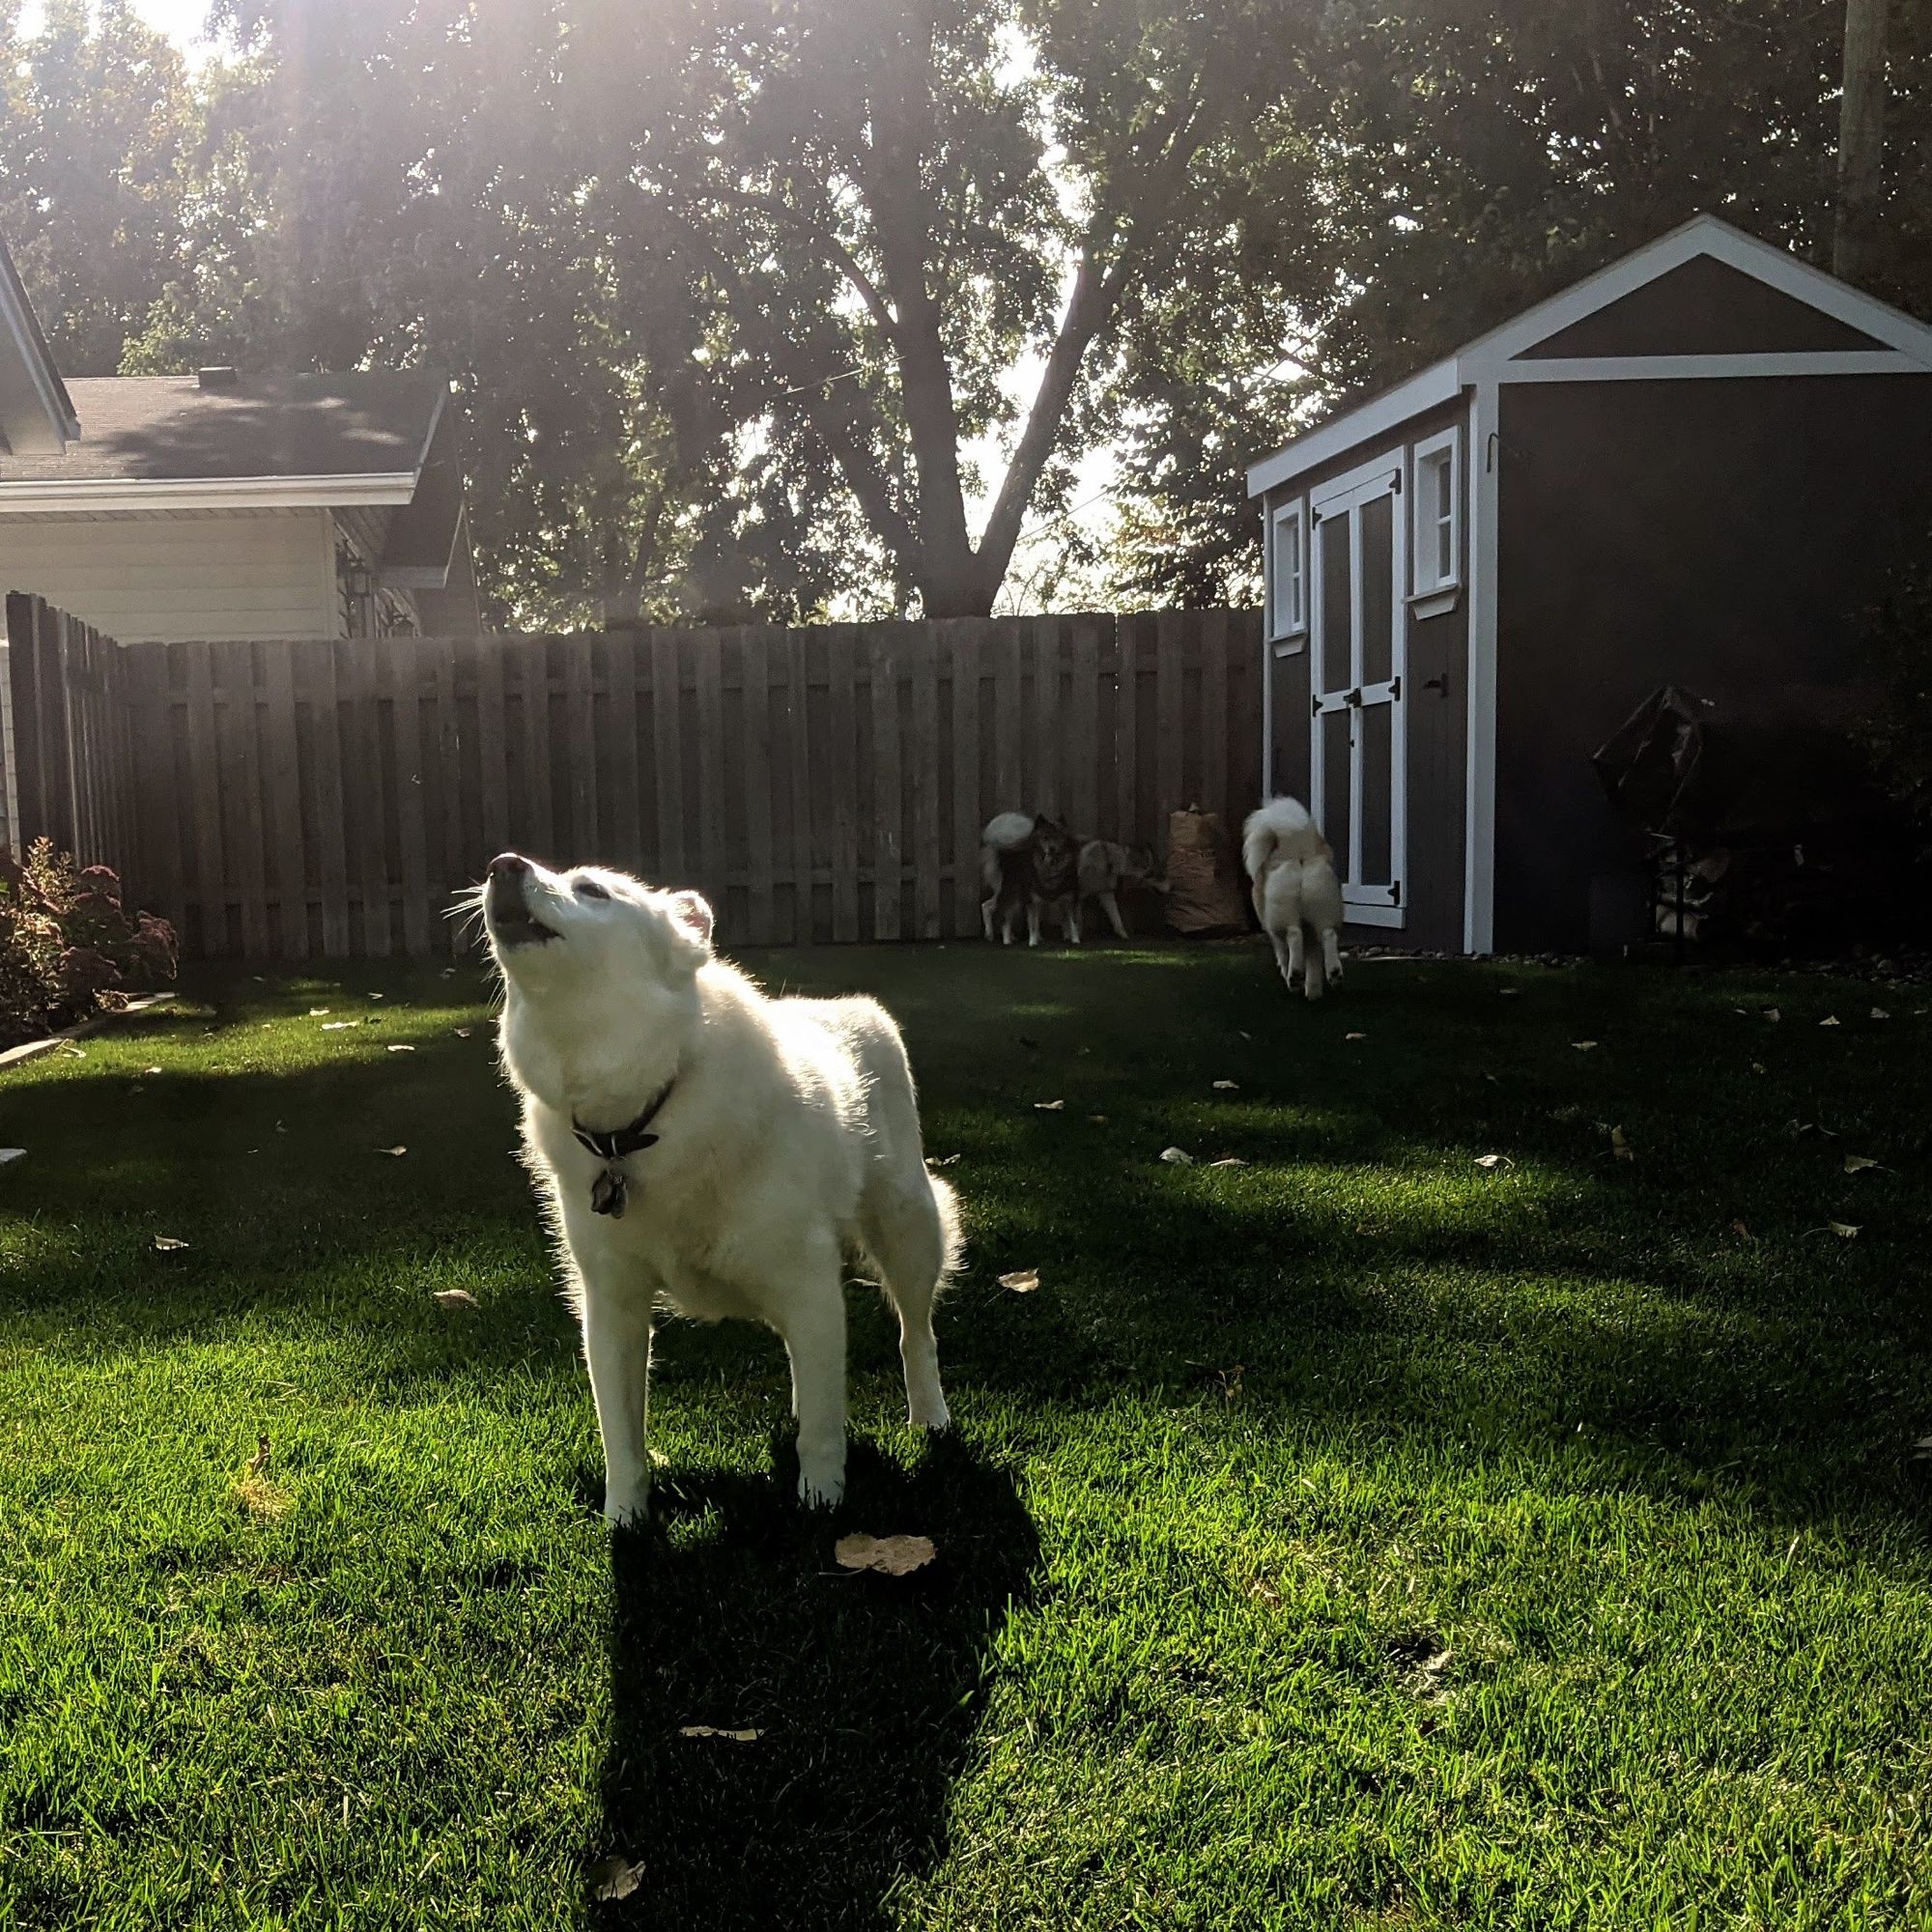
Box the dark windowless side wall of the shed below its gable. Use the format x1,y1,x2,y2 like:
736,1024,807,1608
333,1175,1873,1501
1495,375,1932,951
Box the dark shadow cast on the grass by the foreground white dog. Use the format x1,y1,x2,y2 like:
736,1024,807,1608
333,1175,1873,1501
585,1437,1039,1932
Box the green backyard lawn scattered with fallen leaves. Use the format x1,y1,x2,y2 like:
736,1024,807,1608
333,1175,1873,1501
0,945,1932,1932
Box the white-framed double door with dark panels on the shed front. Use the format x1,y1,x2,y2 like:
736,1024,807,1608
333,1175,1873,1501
1308,452,1408,925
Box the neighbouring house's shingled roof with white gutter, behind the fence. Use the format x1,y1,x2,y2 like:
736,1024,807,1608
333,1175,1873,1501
0,369,448,510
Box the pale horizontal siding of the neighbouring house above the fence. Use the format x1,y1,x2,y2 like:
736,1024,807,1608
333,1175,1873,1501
0,510,340,643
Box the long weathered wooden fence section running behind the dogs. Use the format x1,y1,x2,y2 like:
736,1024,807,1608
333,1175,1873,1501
3,611,1260,958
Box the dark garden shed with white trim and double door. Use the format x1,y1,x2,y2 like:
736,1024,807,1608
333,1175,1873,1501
1248,214,1932,952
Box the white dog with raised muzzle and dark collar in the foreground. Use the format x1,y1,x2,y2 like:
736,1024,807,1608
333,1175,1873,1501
483,852,958,1522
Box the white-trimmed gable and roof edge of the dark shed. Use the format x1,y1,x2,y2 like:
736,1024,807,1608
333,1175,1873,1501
1248,214,1932,497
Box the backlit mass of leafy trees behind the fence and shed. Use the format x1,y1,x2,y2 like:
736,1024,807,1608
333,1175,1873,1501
0,0,1932,624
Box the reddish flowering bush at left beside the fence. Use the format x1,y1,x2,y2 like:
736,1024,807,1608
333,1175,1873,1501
0,838,178,1045
